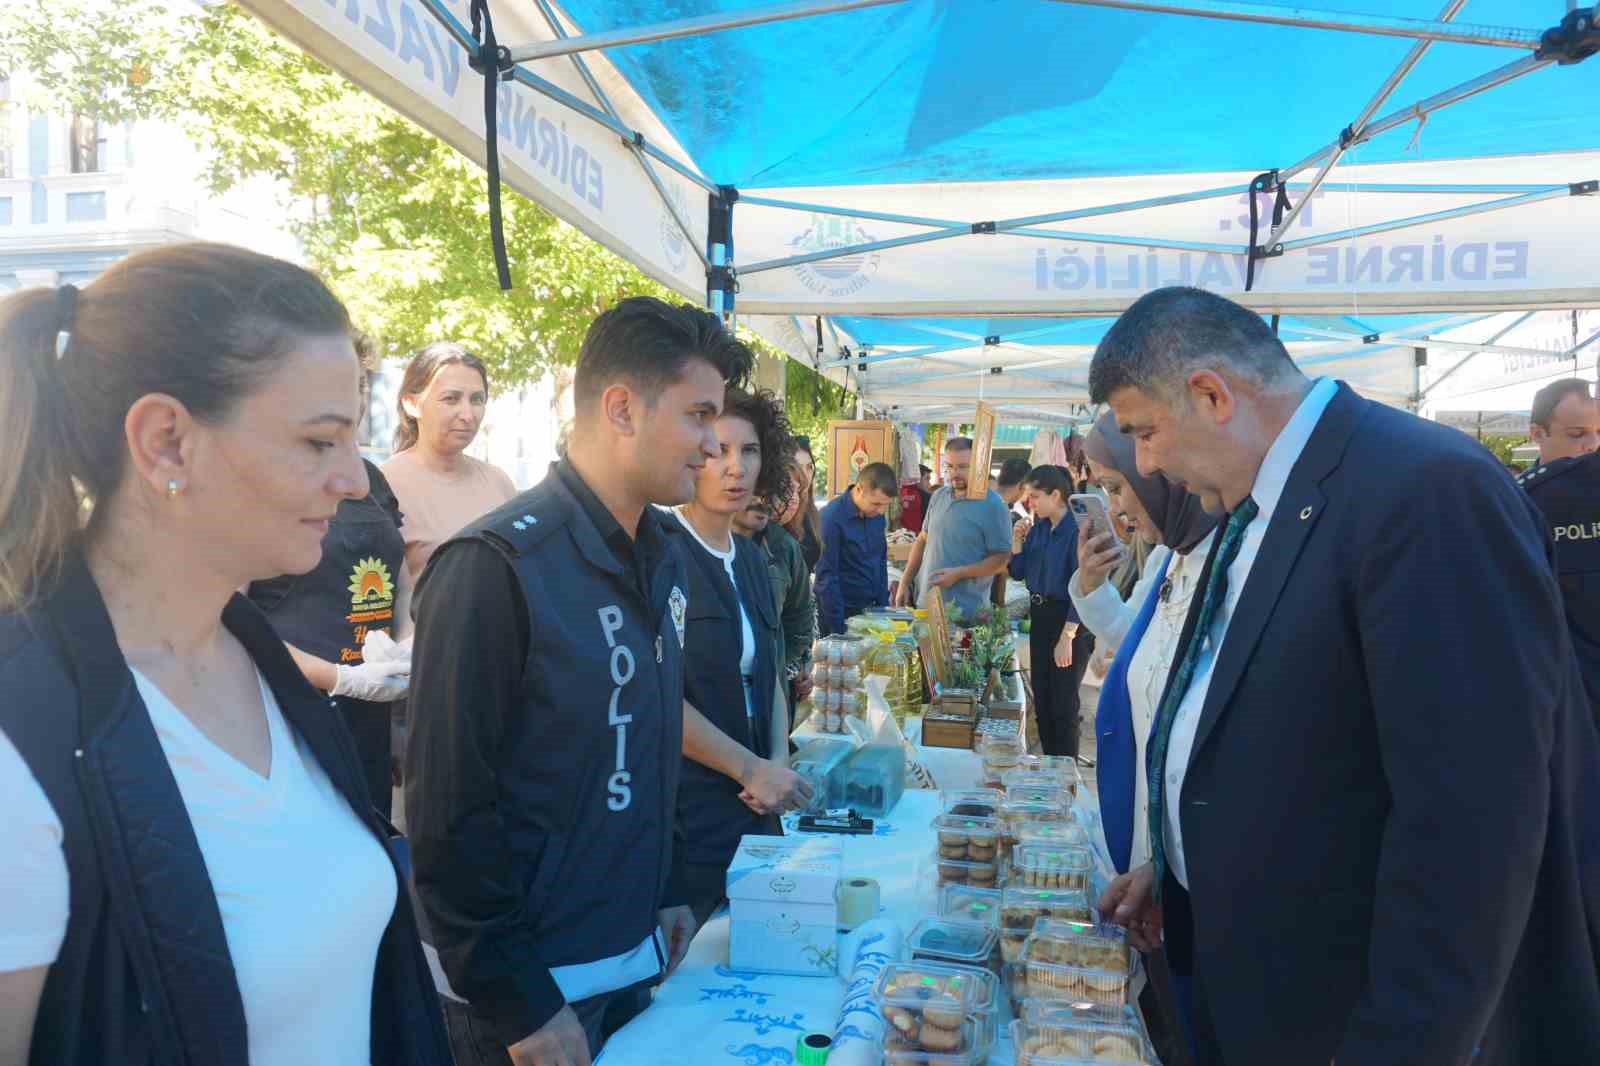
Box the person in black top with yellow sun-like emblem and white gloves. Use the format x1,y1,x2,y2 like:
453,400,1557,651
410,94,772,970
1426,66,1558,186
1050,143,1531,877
246,336,411,818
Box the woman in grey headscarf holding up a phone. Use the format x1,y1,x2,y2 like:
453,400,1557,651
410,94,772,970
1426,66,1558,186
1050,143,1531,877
1067,406,1216,1061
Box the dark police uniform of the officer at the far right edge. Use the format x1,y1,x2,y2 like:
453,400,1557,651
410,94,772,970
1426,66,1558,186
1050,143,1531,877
1517,453,1600,720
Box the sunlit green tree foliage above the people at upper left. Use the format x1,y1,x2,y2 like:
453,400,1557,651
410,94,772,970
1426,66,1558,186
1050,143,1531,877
0,0,688,386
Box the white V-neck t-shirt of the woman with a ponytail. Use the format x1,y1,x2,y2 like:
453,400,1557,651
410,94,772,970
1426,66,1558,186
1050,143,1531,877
0,659,397,1066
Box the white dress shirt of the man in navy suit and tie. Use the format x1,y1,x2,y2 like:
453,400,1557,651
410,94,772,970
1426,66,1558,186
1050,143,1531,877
1163,378,1339,888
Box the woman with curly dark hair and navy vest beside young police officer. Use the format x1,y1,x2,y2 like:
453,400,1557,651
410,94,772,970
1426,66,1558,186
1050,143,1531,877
664,389,810,925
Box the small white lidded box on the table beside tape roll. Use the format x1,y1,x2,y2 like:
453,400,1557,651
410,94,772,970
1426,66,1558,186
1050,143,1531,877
728,836,840,976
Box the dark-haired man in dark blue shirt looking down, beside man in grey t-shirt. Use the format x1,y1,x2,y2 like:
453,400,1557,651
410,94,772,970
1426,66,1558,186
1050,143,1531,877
816,463,899,637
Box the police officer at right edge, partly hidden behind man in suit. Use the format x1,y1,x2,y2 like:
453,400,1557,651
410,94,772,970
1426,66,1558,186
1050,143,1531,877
1517,378,1600,720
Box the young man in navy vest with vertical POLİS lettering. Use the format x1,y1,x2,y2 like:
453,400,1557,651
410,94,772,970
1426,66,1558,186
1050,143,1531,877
405,298,752,1066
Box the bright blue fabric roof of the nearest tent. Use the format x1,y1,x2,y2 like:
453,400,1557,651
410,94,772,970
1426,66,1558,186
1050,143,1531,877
553,0,1600,189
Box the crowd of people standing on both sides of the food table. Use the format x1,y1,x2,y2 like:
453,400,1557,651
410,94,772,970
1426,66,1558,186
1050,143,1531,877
0,245,1600,1066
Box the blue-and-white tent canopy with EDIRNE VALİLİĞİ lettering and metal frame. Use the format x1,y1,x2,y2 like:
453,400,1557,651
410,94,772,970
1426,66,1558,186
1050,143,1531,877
228,0,1600,421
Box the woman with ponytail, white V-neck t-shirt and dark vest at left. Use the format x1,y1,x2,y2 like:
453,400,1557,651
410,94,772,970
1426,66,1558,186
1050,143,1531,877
0,243,450,1066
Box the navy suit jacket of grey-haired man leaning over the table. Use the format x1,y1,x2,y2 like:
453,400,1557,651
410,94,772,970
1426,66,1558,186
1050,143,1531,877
1179,386,1600,1066
